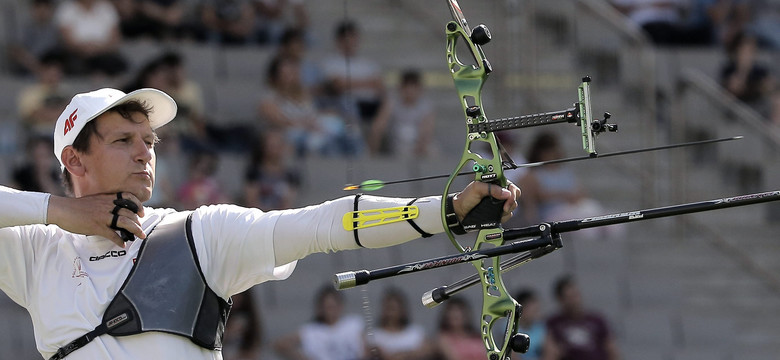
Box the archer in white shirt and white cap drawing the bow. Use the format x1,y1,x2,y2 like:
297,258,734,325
0,89,520,360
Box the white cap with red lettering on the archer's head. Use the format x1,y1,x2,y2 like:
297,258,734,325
54,88,176,166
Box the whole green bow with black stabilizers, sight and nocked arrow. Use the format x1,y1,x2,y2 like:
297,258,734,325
334,0,780,360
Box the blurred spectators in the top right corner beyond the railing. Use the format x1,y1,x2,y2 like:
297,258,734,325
610,0,780,122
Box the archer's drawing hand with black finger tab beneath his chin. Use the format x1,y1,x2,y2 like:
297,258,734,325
47,192,146,248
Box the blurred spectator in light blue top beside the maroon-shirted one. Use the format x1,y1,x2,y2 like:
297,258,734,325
514,289,555,360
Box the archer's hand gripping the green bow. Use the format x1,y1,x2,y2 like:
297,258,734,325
452,181,520,222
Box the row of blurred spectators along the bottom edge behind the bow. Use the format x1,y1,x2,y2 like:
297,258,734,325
224,275,620,360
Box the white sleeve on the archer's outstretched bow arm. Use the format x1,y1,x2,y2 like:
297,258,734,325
192,196,444,298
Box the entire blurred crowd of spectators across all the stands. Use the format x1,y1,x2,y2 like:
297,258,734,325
0,0,780,360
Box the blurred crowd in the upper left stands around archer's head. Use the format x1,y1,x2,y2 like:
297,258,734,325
0,0,442,210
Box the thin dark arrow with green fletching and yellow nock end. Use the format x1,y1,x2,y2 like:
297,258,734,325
343,136,744,191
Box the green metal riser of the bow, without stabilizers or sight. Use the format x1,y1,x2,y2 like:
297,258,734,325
442,4,521,360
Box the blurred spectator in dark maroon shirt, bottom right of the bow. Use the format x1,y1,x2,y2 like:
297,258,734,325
547,276,619,360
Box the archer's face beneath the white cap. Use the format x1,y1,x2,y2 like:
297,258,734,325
81,111,156,202
